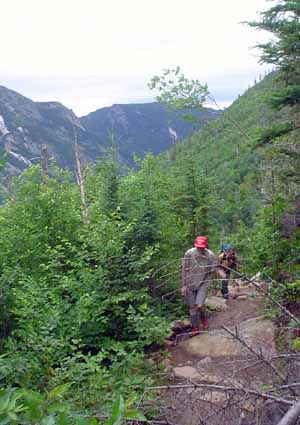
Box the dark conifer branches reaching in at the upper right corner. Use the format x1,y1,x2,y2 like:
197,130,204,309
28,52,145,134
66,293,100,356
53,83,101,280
249,0,300,143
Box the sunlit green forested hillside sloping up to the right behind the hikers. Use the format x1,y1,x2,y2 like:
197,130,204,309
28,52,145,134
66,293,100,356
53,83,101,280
157,74,280,240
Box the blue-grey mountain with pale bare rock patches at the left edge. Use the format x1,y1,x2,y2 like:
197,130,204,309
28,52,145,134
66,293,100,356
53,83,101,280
0,86,104,173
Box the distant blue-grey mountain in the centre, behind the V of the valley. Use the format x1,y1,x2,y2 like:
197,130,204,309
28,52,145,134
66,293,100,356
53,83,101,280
80,103,219,162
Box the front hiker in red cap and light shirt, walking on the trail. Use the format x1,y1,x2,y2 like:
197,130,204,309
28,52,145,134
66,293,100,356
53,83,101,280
181,236,226,332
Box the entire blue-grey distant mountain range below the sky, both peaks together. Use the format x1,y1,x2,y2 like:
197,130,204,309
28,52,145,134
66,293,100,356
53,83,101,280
0,86,216,173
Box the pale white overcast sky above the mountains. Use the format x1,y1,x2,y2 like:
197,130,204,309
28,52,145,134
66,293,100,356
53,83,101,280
0,0,270,116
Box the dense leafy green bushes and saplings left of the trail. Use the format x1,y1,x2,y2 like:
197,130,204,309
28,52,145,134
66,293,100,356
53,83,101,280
0,164,167,410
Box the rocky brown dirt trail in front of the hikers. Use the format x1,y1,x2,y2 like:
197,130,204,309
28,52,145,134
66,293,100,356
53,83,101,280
144,286,280,425
